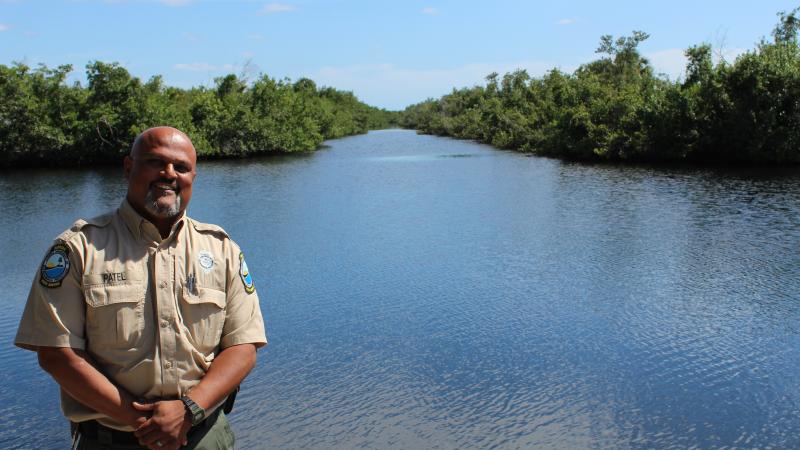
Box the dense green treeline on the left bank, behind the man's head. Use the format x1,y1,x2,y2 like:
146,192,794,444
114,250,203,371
0,62,398,167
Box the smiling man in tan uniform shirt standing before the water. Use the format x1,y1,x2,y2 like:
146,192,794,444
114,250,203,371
15,127,266,450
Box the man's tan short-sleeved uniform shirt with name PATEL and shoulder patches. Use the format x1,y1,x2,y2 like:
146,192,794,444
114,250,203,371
15,200,267,431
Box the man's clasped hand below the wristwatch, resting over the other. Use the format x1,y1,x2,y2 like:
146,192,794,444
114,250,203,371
133,400,192,450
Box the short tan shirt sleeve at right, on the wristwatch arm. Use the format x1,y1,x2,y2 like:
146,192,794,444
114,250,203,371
220,241,267,349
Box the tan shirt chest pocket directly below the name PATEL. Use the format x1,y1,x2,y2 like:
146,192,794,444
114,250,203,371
84,282,145,348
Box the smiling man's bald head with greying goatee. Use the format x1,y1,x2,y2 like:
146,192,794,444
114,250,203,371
124,127,197,228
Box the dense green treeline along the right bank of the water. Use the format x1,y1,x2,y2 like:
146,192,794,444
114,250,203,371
403,8,800,164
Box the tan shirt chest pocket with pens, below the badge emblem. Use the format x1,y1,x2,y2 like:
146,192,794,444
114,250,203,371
180,286,226,354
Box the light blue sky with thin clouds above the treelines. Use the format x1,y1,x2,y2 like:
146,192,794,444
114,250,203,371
0,0,800,110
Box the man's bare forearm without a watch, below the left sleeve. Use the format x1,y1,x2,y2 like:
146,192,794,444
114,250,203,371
38,347,147,428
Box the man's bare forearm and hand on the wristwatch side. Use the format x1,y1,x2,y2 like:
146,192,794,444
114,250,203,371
134,344,256,449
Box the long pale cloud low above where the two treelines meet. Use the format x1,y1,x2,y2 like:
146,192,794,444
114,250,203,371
305,61,560,109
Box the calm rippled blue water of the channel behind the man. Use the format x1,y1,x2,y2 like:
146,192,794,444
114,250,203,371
0,131,800,449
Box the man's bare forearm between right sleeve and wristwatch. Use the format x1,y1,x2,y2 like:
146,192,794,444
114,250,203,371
184,344,256,409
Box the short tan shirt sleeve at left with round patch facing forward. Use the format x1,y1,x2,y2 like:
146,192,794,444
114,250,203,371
14,241,86,351
